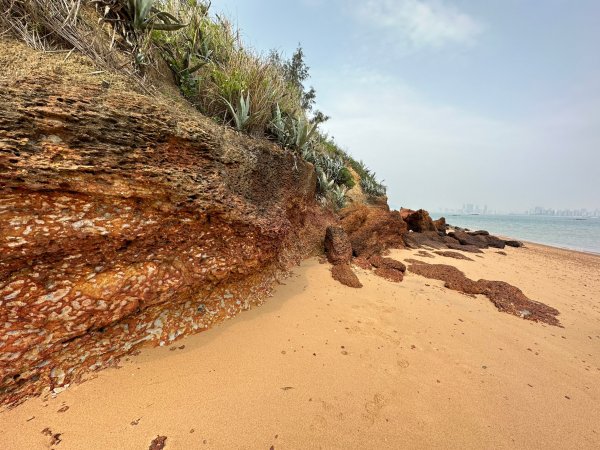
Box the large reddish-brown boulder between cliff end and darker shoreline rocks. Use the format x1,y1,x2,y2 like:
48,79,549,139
341,205,408,258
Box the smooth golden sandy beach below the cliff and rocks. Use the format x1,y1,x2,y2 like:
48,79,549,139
0,244,600,450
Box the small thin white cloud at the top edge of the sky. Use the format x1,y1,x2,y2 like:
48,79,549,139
353,0,483,48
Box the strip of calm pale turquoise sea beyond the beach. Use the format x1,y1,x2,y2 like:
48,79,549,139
431,213,600,253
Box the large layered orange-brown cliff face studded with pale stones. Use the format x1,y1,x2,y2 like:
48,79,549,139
0,43,330,404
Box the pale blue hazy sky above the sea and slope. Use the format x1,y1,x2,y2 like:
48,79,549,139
212,0,600,212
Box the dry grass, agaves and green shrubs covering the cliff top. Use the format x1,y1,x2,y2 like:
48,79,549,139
0,0,385,208
